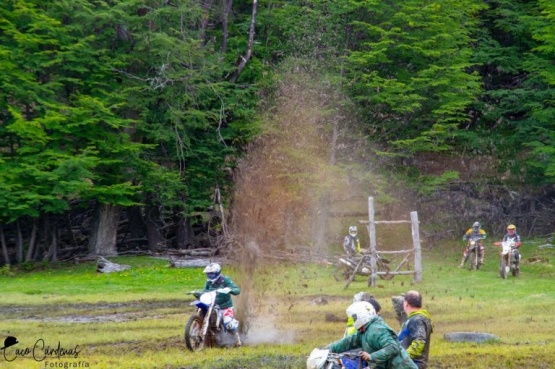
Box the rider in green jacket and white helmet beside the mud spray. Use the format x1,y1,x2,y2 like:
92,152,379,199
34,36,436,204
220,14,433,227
202,263,242,346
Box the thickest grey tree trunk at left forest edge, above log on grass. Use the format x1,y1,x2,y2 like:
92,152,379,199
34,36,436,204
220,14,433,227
89,203,121,256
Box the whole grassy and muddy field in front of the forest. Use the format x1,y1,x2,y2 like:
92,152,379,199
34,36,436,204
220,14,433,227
0,241,555,369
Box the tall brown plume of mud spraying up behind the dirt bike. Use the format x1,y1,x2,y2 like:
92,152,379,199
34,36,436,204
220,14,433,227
231,73,394,345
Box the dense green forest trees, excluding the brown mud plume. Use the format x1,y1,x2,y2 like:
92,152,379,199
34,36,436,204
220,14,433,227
0,0,555,262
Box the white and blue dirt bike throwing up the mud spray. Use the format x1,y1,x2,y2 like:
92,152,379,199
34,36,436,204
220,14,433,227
185,290,240,351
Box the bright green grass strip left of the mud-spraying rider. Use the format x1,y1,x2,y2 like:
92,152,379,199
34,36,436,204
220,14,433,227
0,257,204,304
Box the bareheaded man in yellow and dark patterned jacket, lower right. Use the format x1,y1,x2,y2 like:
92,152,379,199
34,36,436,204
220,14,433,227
399,291,433,369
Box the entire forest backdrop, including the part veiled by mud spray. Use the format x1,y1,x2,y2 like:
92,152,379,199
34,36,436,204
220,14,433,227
0,0,555,265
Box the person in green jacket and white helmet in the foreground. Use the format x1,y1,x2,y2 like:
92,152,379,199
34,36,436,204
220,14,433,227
326,301,418,369
